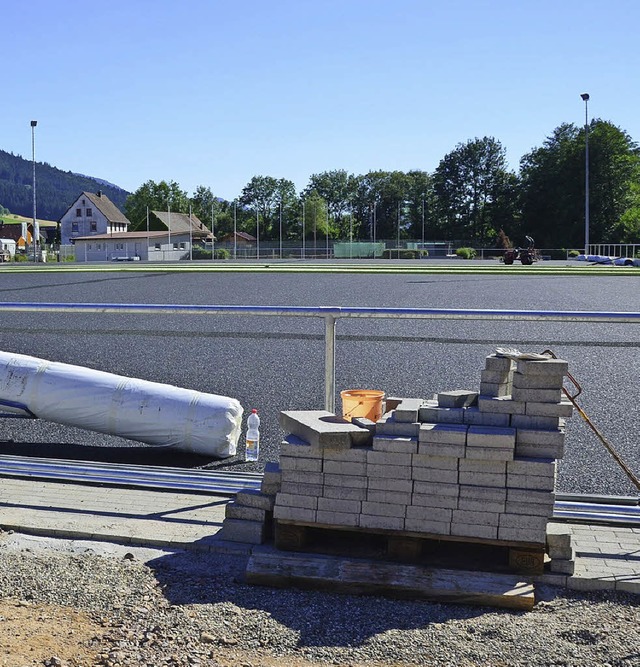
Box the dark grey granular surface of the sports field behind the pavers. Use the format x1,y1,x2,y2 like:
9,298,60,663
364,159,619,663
0,264,640,495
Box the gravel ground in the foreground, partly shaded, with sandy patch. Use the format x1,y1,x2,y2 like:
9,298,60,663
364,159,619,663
0,533,640,667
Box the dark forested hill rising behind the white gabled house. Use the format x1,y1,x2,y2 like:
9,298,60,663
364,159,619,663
0,150,129,220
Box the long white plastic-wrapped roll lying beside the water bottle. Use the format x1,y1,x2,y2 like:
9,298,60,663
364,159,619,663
0,352,242,458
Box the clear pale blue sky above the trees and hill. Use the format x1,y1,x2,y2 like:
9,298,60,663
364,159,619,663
0,0,640,199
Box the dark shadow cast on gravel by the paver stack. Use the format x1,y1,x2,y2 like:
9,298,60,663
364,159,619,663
147,552,500,647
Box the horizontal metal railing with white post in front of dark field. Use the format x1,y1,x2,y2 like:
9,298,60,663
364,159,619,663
0,301,640,412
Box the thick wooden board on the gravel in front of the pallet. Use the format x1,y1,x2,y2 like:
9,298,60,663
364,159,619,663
246,547,535,610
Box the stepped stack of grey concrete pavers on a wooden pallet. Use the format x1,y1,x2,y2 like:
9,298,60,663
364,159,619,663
222,355,572,568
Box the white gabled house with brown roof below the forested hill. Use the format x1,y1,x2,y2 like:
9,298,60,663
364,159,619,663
60,192,131,245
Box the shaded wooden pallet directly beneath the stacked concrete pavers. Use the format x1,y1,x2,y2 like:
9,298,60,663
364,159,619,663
274,520,545,575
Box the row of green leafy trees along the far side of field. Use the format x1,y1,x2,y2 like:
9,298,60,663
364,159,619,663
125,119,640,248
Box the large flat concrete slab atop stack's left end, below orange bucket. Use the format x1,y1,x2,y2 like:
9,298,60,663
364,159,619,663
280,410,371,449
